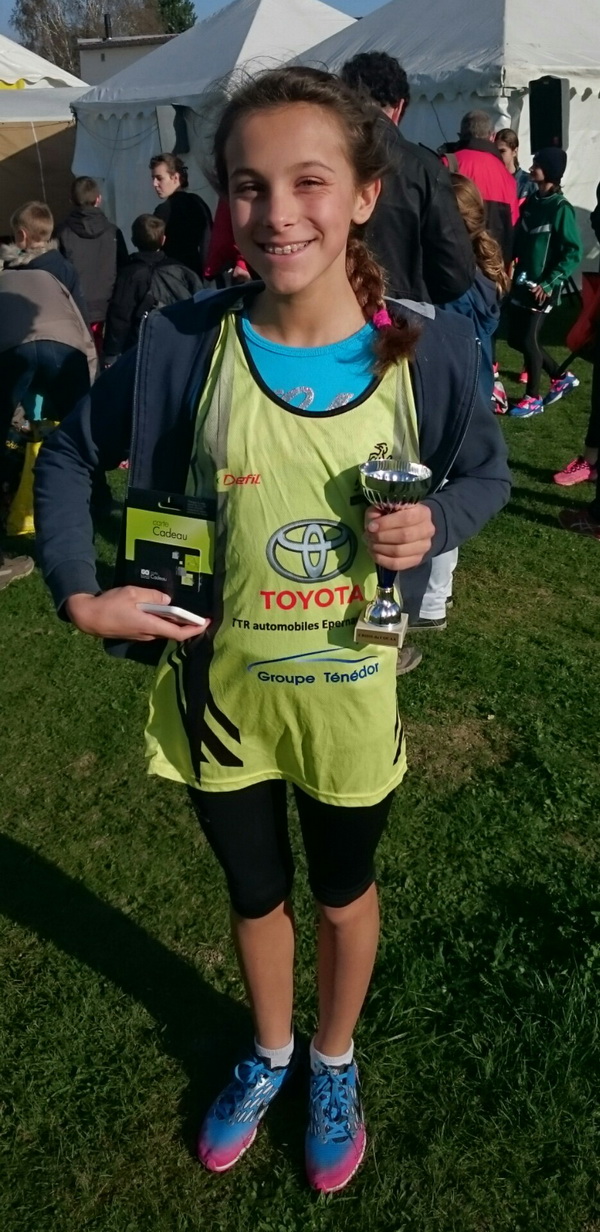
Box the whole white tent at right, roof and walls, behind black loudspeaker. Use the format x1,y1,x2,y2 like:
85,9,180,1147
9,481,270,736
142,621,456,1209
297,0,600,267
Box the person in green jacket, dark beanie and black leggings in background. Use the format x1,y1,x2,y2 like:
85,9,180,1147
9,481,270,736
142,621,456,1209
509,145,583,419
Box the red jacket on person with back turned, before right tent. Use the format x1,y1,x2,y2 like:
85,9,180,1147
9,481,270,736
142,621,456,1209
445,139,519,265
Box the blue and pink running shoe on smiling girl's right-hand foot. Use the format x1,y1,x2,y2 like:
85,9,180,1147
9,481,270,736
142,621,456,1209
306,1062,367,1194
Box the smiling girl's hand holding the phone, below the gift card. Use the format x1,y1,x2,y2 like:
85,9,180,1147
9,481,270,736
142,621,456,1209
65,586,205,642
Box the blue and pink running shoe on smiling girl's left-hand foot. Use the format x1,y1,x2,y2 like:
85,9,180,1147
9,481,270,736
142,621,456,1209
197,1052,297,1172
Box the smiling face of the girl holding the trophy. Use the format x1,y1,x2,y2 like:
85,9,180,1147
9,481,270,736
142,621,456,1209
225,102,379,297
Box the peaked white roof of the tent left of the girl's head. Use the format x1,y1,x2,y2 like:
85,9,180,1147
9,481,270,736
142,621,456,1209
78,0,355,116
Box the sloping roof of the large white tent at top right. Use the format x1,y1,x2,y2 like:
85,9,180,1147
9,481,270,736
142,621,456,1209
297,0,600,99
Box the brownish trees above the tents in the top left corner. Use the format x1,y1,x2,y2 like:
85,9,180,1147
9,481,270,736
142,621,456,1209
10,0,163,76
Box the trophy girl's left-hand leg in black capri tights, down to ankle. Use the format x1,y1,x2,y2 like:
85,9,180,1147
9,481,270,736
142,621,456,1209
190,782,294,1048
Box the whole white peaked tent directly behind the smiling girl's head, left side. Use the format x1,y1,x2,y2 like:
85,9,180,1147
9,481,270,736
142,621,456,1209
74,0,354,235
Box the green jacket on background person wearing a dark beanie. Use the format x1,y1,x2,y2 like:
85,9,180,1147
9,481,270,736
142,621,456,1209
511,188,583,308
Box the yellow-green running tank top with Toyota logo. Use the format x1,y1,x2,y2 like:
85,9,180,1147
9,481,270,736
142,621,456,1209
147,314,418,806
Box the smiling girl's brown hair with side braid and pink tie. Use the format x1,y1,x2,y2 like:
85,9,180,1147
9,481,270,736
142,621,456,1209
213,65,419,376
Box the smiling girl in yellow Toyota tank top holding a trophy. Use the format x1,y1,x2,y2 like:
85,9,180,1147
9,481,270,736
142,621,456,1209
37,68,509,1190
